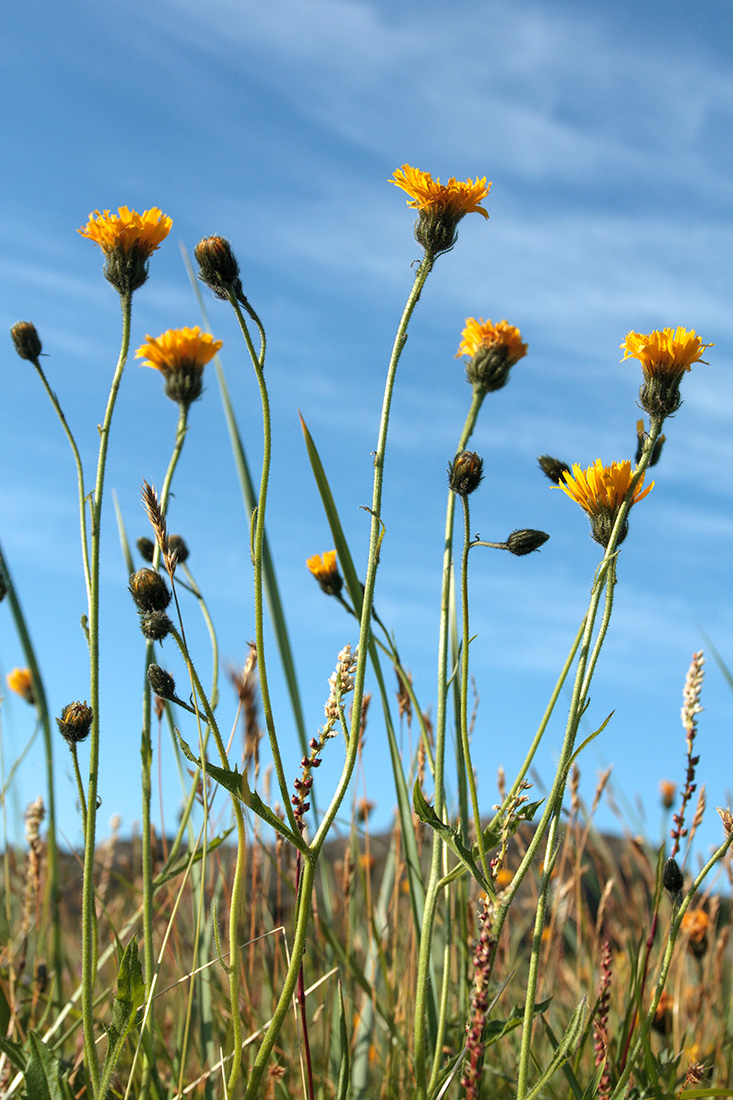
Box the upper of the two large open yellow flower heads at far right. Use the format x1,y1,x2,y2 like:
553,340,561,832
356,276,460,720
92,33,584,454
621,328,714,420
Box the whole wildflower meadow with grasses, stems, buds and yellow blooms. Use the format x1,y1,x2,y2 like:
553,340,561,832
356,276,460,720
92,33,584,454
0,176,733,1100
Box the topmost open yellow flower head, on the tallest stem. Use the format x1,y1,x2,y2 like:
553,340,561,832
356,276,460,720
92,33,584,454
390,164,491,255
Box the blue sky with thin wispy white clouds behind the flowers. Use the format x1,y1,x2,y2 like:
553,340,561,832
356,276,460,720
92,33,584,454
0,0,733,862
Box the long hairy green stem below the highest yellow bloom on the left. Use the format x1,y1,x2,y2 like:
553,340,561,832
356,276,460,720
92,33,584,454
81,292,132,1100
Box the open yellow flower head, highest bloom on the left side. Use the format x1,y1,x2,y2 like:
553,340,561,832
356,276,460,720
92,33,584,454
79,207,173,295
